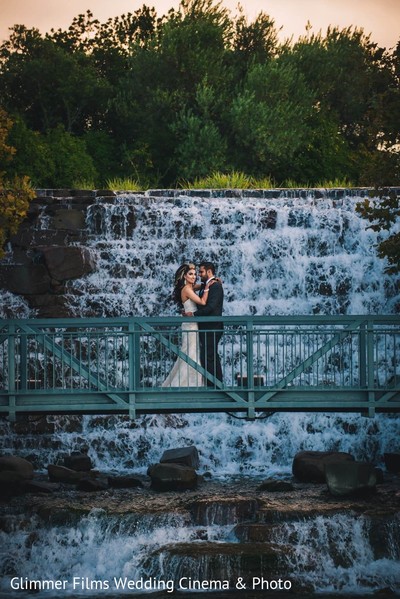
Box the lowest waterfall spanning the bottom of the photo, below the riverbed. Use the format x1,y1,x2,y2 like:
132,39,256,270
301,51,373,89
0,508,400,599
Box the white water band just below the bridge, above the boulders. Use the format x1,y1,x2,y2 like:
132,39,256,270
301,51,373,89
0,413,400,480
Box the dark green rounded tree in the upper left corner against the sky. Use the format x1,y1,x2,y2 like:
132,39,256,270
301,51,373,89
0,25,111,133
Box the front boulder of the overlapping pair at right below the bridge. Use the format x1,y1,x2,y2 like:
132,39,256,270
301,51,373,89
325,461,377,497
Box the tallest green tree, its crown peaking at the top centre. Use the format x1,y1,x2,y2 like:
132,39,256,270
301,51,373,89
108,0,232,185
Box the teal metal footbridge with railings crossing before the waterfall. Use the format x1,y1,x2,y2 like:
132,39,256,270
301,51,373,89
0,315,400,420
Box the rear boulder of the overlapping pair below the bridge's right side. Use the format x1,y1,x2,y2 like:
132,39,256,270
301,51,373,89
292,451,354,483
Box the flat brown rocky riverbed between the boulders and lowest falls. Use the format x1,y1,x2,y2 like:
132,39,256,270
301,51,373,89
4,475,400,523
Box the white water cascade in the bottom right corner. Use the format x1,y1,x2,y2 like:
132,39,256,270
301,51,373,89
275,514,400,595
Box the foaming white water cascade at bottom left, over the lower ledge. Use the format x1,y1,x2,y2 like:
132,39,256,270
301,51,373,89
0,509,232,596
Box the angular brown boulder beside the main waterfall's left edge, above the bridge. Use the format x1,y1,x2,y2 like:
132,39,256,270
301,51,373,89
41,246,95,281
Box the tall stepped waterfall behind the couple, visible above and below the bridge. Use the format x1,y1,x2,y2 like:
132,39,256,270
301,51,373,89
51,191,400,476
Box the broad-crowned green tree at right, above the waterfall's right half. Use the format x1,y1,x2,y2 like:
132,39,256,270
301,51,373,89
282,27,393,184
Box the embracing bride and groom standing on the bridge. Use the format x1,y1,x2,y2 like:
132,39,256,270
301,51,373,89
162,262,224,387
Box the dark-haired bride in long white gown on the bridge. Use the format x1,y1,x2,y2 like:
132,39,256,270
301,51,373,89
162,263,214,387
